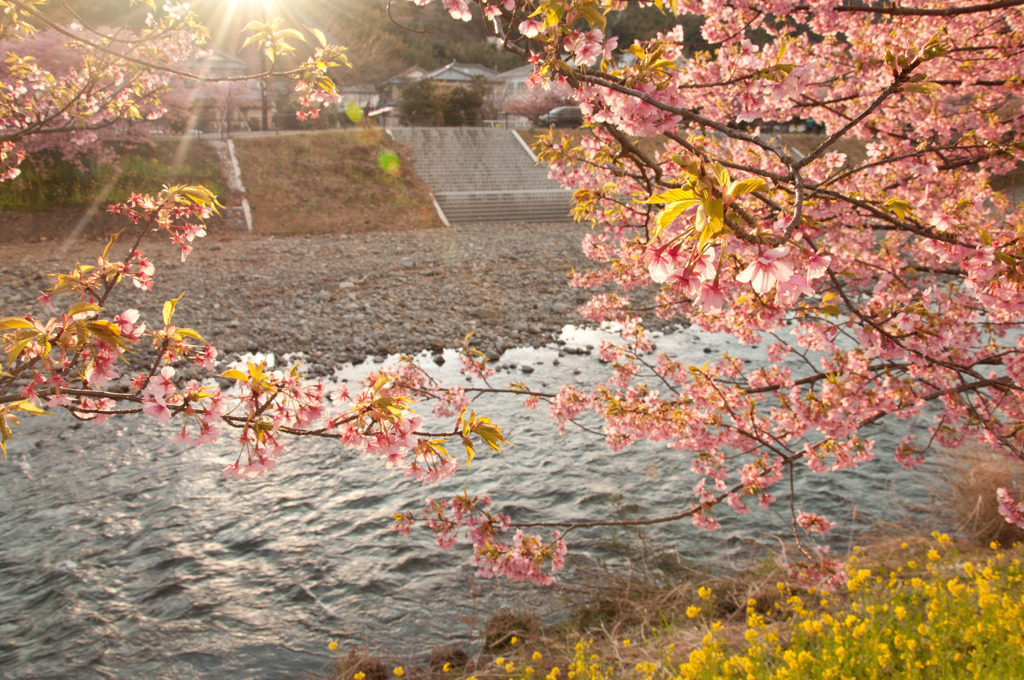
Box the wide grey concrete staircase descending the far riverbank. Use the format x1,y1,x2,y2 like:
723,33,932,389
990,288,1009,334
388,128,572,224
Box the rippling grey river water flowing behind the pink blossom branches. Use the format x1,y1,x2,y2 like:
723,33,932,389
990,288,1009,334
0,329,940,679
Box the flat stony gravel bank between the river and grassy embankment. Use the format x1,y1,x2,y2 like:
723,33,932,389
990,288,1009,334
0,224,667,375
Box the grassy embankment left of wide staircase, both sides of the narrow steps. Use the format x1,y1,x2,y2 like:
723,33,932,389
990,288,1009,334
0,129,441,242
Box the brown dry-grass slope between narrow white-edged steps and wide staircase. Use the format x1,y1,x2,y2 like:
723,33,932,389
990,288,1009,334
236,128,441,236
